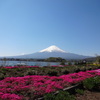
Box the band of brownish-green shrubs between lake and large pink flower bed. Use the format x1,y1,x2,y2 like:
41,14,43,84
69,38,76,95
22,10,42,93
0,65,100,80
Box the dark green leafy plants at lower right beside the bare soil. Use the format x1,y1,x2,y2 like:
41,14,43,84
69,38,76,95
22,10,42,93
44,76,100,100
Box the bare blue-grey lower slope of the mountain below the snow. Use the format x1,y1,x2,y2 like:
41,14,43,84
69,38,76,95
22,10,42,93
19,52,88,59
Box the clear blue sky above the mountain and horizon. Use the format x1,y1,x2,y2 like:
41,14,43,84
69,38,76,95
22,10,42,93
0,0,100,56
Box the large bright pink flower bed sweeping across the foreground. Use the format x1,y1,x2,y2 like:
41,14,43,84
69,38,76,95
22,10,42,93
0,70,100,100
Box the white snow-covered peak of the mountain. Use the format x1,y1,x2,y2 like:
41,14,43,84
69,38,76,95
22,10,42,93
40,45,66,53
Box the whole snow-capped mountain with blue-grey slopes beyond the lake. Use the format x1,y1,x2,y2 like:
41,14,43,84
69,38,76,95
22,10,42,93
11,45,89,60
